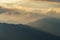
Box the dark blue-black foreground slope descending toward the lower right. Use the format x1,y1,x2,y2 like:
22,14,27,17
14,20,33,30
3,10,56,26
0,23,60,40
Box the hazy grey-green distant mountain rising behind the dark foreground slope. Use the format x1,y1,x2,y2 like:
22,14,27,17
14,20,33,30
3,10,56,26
29,17,60,36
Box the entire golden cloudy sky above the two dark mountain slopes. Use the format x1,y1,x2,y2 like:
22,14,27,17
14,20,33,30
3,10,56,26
0,0,60,36
